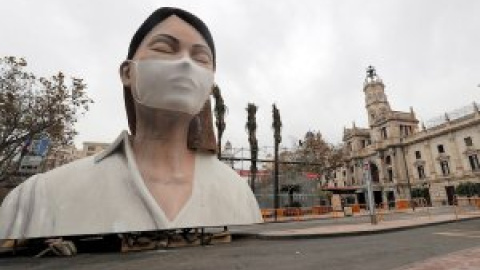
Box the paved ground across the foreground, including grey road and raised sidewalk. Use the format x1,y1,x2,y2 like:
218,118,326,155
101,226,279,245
0,212,480,270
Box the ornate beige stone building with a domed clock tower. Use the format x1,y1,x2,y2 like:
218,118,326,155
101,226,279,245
325,67,480,206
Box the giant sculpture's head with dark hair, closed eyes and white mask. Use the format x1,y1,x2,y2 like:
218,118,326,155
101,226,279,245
120,7,216,152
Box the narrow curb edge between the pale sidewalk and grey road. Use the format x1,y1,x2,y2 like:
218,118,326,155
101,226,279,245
232,216,480,240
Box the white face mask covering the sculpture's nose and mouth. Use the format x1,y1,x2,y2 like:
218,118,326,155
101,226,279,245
132,57,213,115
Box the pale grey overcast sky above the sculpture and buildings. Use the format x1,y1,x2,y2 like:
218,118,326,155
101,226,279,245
0,0,480,152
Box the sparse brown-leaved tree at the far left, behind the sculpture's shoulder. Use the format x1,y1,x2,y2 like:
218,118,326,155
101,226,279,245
0,56,92,181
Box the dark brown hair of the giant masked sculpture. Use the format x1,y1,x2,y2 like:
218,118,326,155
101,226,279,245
123,7,216,153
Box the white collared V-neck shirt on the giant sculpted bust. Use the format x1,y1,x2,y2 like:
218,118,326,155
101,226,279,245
0,131,263,239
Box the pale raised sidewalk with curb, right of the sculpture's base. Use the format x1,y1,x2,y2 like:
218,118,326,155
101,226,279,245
231,211,480,240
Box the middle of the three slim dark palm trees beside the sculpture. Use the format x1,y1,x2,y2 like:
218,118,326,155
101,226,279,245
246,103,258,192
